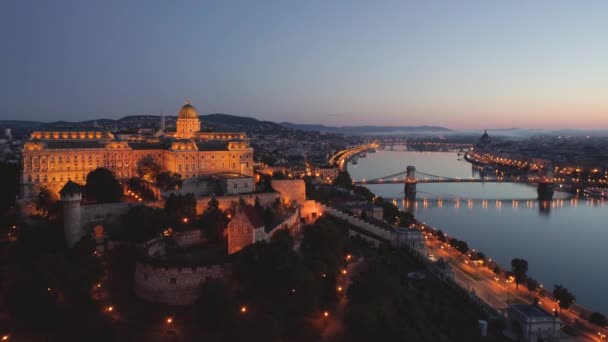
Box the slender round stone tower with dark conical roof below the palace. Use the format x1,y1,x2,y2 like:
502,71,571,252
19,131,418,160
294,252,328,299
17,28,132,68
59,181,85,248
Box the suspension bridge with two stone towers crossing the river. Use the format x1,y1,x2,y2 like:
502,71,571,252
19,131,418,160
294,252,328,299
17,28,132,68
353,165,569,201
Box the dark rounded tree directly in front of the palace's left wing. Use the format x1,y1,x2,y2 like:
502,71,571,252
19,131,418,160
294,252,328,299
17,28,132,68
84,167,123,203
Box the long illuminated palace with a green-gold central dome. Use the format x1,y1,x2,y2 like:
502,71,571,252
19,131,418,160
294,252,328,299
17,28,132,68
21,102,253,198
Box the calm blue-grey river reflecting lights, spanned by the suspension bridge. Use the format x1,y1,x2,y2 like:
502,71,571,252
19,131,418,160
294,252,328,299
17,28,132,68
348,146,608,314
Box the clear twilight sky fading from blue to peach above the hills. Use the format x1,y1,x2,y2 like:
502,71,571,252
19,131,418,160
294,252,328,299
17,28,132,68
0,0,608,129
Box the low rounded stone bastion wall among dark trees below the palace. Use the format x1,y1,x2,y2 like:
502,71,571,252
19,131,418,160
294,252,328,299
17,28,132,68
134,260,230,305
